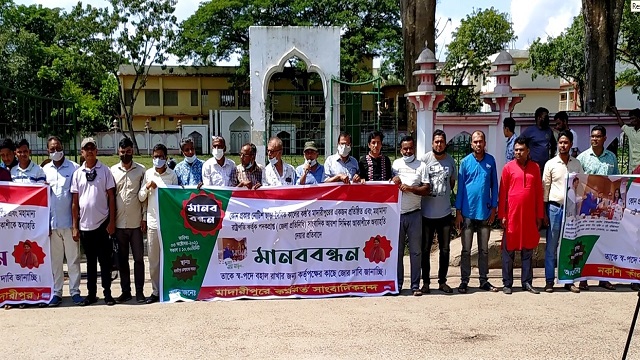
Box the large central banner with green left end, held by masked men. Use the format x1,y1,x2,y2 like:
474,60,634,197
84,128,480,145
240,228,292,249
158,184,400,301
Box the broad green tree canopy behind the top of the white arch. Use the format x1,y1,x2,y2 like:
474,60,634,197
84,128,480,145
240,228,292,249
172,0,402,87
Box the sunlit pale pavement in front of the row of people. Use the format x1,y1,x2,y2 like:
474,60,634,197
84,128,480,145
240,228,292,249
0,258,640,360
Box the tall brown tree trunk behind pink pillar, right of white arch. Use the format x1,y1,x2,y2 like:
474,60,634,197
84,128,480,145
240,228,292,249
400,0,436,134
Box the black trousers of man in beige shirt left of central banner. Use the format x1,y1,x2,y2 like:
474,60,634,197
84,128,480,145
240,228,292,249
116,228,144,294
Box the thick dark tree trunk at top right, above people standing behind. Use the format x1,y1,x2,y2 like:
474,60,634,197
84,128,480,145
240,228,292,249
582,0,625,113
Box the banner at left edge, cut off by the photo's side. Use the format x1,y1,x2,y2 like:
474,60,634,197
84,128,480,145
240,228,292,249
0,182,53,306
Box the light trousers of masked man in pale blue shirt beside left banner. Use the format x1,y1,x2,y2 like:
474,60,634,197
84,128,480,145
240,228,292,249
50,229,80,297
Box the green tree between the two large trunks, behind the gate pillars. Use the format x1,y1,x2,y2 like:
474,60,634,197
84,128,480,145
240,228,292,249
442,7,516,112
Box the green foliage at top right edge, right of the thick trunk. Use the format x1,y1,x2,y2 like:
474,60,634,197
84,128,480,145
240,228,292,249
617,6,640,100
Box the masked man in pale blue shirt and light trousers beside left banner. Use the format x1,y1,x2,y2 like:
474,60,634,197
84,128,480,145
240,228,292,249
42,136,84,306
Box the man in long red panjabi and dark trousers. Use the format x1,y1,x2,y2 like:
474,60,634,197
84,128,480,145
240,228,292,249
498,137,544,294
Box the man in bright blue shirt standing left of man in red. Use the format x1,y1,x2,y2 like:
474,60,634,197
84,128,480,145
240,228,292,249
456,130,498,294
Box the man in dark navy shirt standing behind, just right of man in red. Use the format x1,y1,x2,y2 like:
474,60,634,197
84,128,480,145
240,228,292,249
522,107,557,178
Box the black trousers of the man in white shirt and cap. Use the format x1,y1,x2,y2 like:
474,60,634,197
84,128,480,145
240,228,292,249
80,219,113,297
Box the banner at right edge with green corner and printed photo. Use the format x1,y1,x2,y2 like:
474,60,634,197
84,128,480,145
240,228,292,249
558,174,640,283
